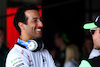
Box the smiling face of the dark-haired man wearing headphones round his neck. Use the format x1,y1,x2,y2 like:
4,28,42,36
25,10,43,39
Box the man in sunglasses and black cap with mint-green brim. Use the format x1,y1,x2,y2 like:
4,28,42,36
79,15,100,67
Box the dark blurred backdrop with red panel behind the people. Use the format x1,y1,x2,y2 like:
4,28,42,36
0,0,100,66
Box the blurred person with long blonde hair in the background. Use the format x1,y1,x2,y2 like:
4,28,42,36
64,44,79,67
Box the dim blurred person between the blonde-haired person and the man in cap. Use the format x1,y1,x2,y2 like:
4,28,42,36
82,37,93,59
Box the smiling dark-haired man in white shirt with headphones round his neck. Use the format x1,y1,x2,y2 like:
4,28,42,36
6,5,55,67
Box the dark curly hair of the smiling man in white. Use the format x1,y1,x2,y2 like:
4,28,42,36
13,4,39,35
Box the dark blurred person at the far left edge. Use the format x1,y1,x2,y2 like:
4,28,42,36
0,27,9,67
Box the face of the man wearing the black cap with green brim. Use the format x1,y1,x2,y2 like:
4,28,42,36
92,28,100,49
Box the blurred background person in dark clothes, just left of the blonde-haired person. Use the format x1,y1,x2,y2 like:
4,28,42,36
54,32,69,67
